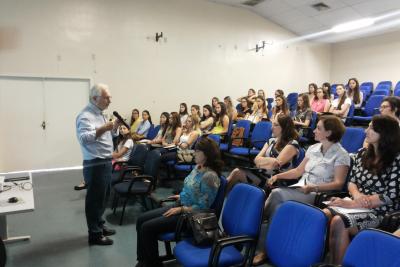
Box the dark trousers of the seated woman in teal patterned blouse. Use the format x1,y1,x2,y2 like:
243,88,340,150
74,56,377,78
136,207,180,267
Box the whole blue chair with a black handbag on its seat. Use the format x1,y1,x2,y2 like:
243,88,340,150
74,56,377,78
174,184,265,267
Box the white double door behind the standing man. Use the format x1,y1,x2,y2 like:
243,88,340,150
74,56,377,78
0,76,90,172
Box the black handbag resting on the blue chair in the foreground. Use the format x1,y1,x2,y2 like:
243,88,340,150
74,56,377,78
186,210,224,246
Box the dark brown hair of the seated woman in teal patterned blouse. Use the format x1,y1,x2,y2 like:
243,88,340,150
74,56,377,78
195,137,224,175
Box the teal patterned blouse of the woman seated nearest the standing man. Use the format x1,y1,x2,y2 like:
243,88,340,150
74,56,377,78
180,167,220,209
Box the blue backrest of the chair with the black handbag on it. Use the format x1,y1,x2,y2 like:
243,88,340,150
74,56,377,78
222,183,265,238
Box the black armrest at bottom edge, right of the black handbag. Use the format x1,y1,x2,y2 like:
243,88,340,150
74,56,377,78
208,235,257,267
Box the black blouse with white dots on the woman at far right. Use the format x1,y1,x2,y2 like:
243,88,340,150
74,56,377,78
350,150,400,215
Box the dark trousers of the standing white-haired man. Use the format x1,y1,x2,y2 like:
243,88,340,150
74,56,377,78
83,159,112,239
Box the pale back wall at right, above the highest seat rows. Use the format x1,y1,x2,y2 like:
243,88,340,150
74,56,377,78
331,31,400,86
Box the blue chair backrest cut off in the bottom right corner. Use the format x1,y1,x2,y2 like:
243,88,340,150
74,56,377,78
342,229,400,267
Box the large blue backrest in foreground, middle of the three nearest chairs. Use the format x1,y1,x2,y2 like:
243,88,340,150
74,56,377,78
265,201,328,267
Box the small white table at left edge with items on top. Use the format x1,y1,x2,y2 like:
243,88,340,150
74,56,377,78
0,172,35,243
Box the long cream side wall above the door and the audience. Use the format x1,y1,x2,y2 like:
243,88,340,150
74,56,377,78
0,0,330,122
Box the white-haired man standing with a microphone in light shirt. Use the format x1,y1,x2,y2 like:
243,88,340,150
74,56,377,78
76,84,119,245
